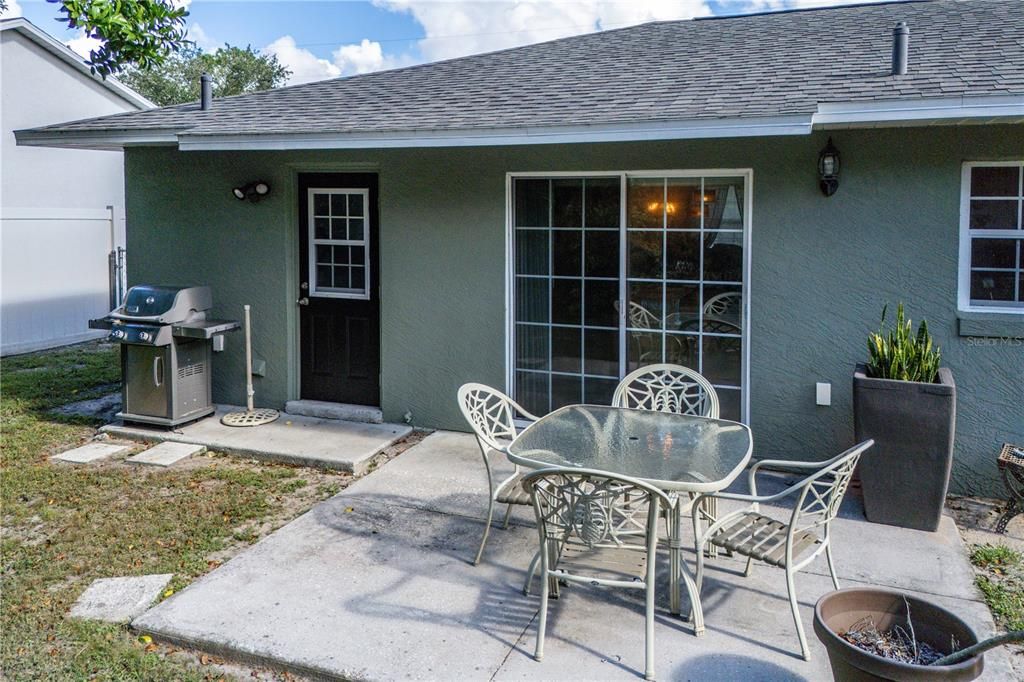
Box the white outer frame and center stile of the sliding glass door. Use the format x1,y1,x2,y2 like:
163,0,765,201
505,168,754,423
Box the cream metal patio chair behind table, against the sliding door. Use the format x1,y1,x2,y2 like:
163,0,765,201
611,365,719,555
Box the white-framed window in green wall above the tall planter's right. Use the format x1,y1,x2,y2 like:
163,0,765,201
958,161,1024,313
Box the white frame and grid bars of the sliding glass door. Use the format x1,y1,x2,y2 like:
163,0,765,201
507,170,752,413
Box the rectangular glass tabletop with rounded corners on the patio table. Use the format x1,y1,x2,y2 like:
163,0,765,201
506,404,753,493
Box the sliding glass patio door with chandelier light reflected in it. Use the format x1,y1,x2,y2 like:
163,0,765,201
510,173,748,419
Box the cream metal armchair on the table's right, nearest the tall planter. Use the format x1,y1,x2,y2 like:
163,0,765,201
694,440,874,660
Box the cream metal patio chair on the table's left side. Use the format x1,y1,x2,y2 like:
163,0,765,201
459,383,538,565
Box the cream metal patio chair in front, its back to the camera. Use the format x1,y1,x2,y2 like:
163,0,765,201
522,468,672,680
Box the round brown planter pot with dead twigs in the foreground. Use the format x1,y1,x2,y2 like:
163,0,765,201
814,588,985,682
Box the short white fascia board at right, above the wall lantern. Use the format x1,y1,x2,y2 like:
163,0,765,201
813,95,1024,128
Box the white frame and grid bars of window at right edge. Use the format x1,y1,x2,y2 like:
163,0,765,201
957,161,1024,314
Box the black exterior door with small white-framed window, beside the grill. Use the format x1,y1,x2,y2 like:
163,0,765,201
298,173,380,406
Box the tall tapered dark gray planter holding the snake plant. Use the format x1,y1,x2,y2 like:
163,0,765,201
853,365,956,530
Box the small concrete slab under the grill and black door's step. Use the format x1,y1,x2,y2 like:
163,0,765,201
100,406,413,474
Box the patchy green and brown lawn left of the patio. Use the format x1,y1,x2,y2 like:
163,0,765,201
0,344,350,680
